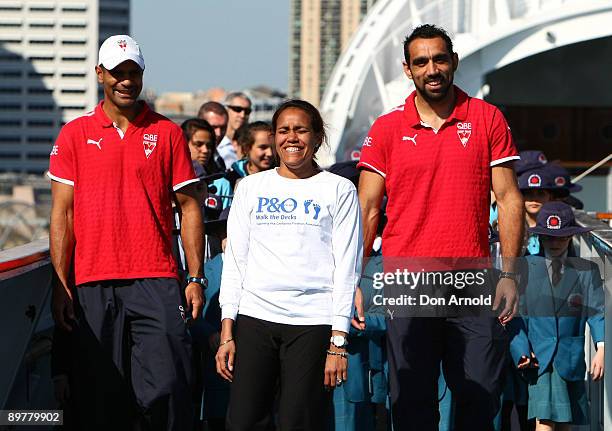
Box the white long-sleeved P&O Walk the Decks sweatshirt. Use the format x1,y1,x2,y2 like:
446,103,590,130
219,169,363,332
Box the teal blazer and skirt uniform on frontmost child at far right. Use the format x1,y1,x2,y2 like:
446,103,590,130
509,256,604,425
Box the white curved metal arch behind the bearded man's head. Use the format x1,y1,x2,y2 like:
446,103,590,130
320,0,612,165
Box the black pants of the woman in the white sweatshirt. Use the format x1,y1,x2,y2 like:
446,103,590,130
226,315,331,431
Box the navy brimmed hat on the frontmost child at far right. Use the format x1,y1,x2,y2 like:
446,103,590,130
529,201,592,236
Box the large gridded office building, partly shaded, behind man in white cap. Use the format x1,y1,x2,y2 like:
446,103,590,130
0,0,130,173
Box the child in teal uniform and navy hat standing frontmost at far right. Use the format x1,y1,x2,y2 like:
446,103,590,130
509,202,604,431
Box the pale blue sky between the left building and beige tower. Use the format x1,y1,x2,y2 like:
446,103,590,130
131,0,289,94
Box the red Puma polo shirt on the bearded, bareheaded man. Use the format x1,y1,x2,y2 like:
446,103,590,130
357,87,519,257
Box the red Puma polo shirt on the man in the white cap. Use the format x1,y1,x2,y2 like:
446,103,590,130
48,102,197,285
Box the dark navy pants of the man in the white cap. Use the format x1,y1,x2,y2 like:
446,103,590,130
71,278,193,430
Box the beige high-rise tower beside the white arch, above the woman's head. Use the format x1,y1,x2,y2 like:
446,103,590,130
289,0,376,106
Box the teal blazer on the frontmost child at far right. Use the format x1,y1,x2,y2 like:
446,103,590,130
508,256,604,381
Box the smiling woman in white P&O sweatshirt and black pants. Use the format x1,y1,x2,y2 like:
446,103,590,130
216,100,362,431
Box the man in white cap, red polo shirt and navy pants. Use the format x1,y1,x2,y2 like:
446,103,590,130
49,35,206,430
